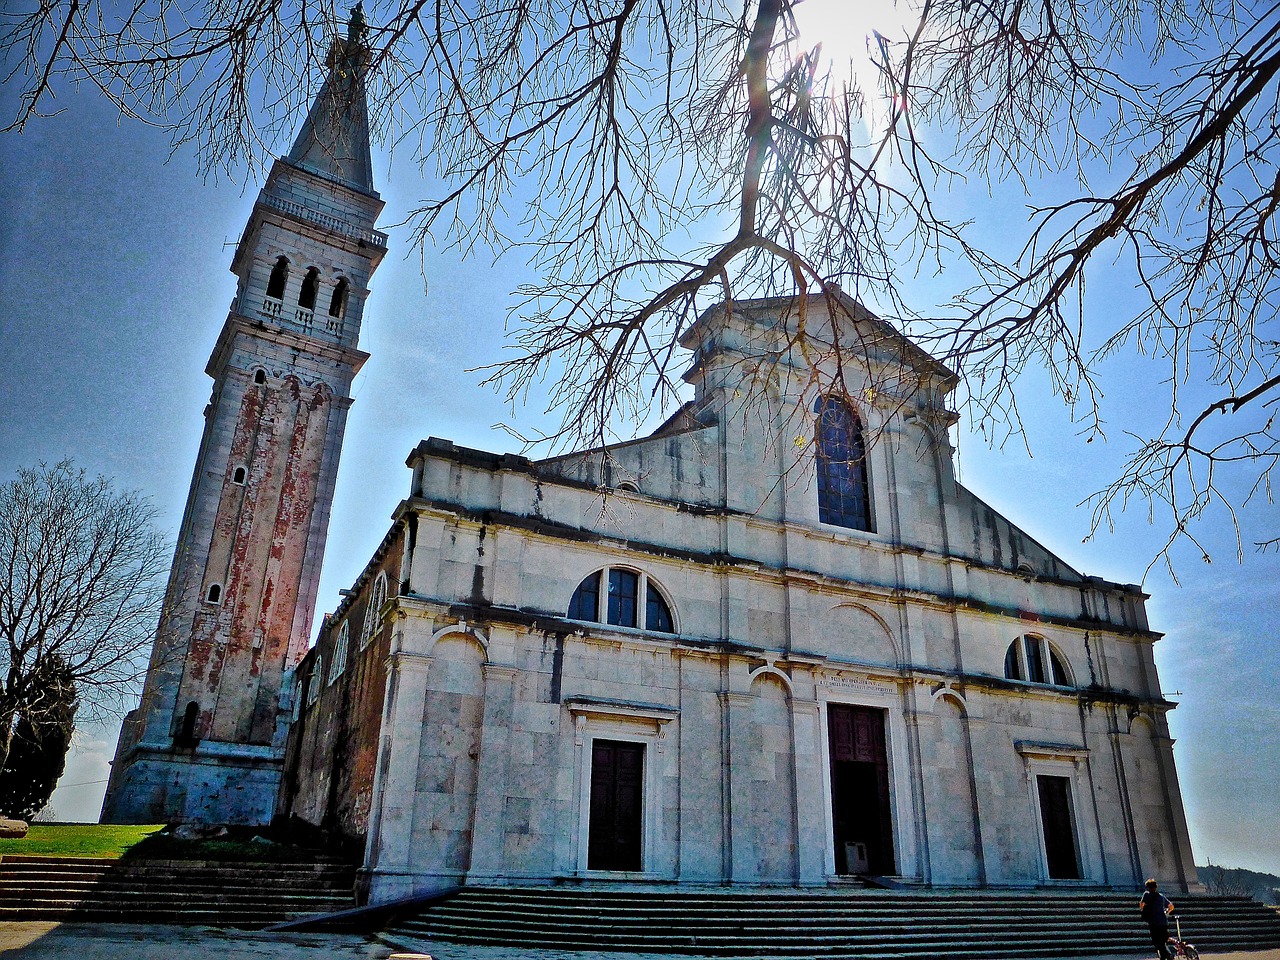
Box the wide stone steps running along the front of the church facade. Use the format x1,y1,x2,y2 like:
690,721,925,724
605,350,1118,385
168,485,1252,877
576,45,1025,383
384,887,1280,960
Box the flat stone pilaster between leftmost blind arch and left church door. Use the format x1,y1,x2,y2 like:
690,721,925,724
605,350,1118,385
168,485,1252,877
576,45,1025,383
467,663,520,882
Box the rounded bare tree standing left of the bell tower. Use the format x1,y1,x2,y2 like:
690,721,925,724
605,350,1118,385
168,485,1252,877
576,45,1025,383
0,461,169,767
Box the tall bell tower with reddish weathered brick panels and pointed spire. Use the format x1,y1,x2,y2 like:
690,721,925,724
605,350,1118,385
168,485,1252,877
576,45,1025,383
102,8,387,824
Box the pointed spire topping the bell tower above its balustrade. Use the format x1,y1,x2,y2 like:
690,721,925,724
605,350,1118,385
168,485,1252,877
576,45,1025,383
285,4,378,196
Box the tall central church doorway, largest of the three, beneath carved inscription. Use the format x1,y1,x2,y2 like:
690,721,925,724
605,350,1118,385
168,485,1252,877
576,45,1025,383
827,703,897,876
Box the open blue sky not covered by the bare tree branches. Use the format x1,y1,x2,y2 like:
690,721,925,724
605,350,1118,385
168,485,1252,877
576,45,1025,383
0,71,1280,873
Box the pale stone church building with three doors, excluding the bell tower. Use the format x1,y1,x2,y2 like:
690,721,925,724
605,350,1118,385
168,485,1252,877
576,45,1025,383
276,296,1196,900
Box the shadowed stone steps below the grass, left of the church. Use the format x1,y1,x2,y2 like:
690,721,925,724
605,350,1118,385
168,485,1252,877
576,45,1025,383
0,856,356,928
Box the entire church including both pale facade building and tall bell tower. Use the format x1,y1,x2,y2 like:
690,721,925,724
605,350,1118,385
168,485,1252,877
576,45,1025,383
104,11,1197,902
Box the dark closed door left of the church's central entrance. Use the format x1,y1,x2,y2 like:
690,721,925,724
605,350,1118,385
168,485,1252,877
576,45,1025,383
586,740,644,870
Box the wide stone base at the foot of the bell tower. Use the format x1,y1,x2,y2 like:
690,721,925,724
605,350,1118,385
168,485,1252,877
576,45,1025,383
101,742,282,827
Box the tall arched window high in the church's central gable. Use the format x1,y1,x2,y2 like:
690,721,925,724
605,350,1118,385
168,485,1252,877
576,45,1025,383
814,397,872,531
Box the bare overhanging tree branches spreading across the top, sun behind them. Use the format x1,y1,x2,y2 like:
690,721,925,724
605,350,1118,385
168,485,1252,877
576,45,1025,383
3,0,1280,570
